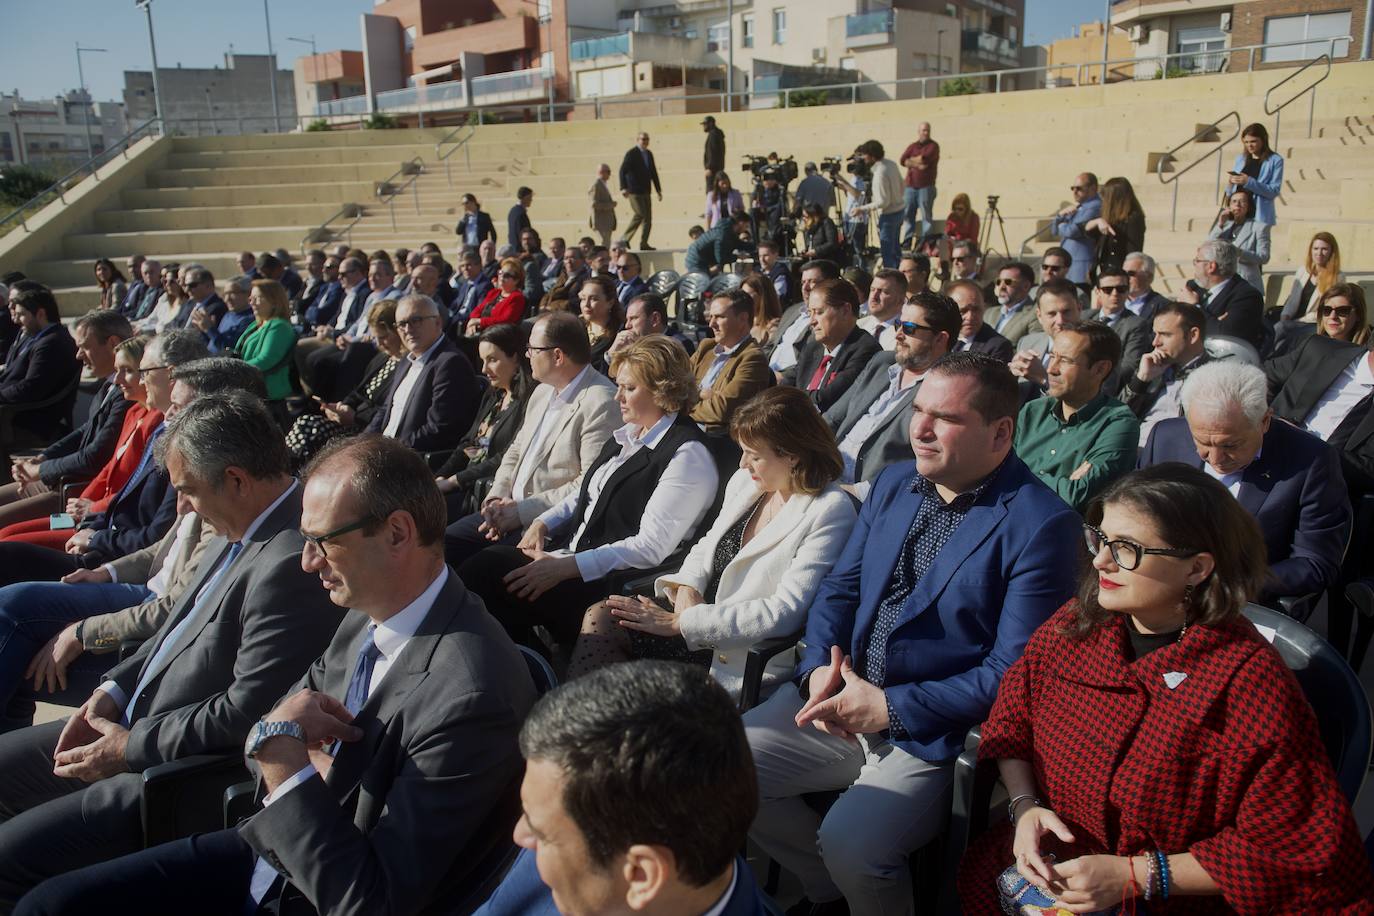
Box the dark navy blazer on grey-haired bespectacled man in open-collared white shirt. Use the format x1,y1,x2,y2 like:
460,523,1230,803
367,338,482,452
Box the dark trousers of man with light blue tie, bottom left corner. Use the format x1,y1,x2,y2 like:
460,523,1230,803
0,722,143,912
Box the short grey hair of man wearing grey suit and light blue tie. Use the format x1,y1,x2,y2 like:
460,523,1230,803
157,391,290,489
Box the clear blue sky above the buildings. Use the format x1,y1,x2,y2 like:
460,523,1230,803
0,0,1105,102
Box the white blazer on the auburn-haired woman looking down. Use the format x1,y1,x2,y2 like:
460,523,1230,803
654,470,859,699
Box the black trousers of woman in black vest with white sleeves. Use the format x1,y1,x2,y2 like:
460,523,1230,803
458,547,610,645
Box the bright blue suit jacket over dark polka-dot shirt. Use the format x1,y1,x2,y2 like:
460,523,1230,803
797,455,1083,762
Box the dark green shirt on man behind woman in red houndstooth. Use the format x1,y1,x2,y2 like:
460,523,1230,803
1015,393,1140,512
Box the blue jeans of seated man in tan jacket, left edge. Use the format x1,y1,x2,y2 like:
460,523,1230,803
0,582,153,732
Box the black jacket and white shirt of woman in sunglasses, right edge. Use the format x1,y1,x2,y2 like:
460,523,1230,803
1264,334,1374,501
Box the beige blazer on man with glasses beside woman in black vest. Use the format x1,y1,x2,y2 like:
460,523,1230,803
488,369,622,526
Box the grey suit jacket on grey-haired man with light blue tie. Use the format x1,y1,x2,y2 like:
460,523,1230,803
109,485,342,772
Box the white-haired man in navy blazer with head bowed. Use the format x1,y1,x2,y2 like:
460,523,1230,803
1136,360,1353,607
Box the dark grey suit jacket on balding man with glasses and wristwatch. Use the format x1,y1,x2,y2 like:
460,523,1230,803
239,571,534,915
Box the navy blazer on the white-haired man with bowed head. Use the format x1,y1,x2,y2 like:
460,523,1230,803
1136,416,1353,603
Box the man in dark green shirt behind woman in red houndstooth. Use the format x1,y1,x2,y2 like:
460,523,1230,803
1015,321,1140,512
